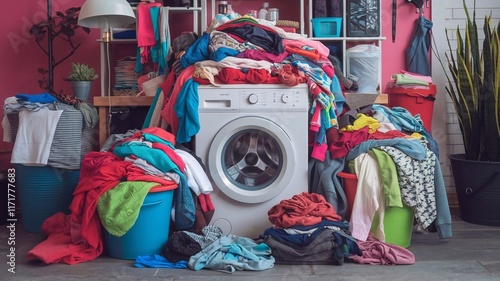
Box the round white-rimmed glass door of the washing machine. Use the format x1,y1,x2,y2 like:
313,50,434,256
208,116,295,203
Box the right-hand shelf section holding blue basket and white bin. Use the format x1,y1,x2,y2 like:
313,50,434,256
301,0,386,94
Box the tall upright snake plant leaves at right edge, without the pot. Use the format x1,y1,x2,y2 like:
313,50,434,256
441,0,500,162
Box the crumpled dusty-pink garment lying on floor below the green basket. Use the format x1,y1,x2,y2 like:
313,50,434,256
348,233,415,265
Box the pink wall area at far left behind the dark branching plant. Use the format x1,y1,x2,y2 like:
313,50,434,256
0,0,100,153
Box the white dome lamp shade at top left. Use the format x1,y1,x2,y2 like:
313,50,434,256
78,0,135,28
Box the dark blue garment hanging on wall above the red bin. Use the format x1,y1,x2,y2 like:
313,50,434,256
406,14,433,76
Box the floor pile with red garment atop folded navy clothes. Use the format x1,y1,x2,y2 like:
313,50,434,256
262,192,361,265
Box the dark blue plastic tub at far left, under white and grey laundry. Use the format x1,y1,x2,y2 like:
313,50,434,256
14,164,80,233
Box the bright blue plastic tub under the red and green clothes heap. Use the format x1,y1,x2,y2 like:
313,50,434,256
104,187,174,260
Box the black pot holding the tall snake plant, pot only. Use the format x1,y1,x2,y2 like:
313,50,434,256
449,154,500,226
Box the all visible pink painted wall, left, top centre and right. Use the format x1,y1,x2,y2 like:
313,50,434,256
0,0,430,154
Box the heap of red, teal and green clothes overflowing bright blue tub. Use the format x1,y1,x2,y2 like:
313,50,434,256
27,128,214,264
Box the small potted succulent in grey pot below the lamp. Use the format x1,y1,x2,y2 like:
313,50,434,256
66,63,99,101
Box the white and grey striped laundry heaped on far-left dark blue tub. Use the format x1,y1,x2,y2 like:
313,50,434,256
2,92,98,169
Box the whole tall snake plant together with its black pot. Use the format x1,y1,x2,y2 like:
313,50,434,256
442,0,500,226
